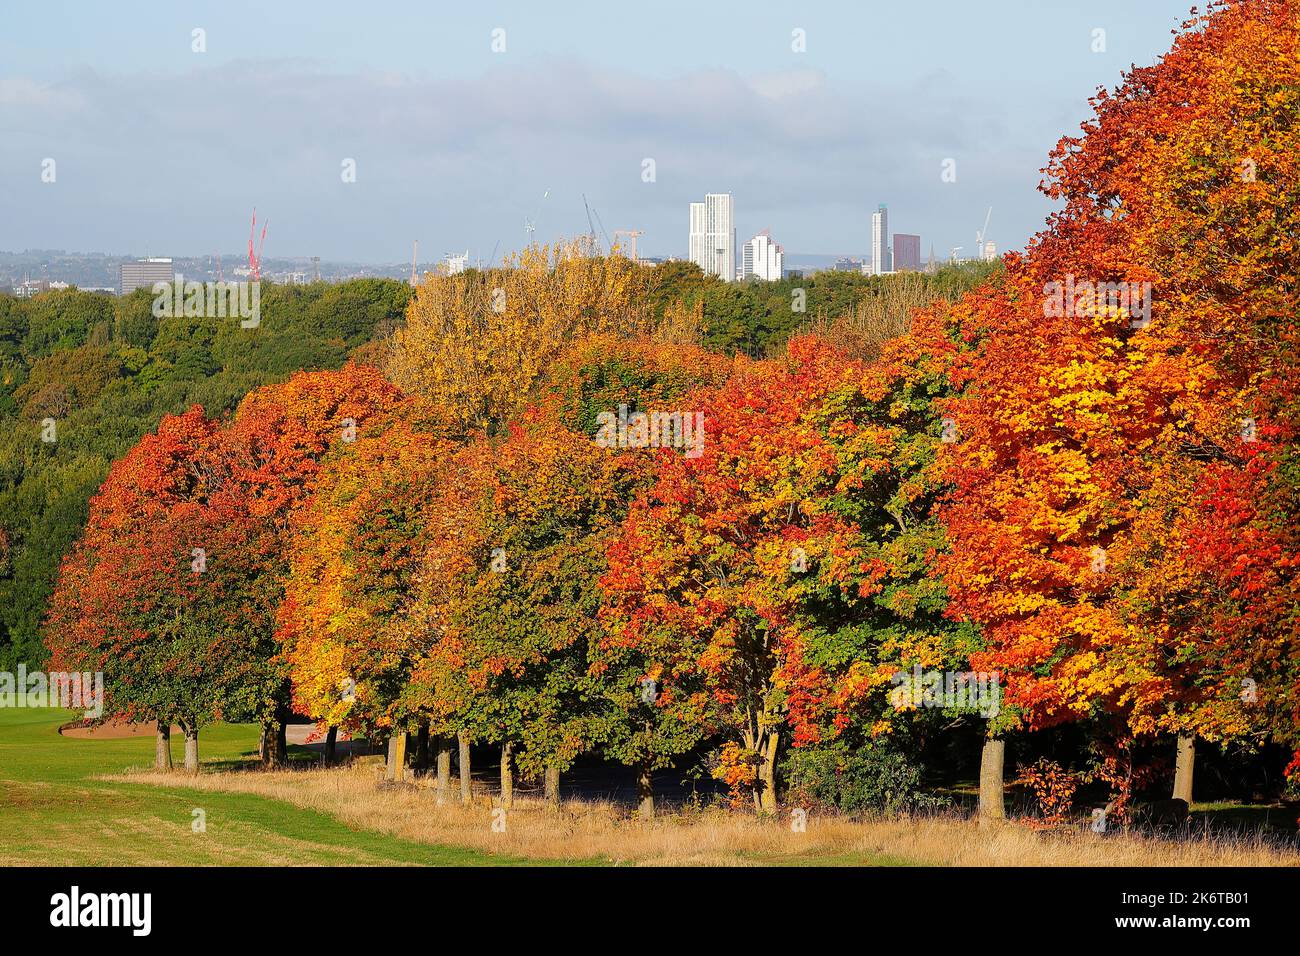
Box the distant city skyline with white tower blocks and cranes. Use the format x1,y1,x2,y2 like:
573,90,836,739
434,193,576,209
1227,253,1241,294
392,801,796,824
0,193,997,298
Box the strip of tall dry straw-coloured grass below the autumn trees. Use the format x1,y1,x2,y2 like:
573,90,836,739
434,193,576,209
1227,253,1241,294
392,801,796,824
112,763,1300,866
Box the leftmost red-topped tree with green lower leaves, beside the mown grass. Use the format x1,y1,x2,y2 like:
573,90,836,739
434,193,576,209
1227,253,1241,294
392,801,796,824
47,408,231,771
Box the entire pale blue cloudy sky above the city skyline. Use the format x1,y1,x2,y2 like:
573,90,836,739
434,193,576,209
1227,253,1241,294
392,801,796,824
0,0,1191,263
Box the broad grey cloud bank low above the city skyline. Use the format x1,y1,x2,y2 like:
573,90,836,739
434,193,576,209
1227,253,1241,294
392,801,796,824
0,60,1041,260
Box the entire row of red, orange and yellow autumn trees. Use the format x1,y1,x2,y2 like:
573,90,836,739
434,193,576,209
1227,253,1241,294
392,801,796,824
48,0,1300,816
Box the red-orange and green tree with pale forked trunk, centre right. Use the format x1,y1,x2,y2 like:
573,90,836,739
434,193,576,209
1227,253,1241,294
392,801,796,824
602,339,977,812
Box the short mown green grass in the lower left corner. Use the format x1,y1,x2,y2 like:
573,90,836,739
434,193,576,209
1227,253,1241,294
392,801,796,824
0,708,524,866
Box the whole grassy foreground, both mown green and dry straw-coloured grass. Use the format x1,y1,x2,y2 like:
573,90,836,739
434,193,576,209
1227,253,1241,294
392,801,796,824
0,709,1300,866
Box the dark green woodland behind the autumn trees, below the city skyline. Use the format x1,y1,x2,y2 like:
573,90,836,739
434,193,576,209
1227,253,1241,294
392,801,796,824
0,257,983,671
